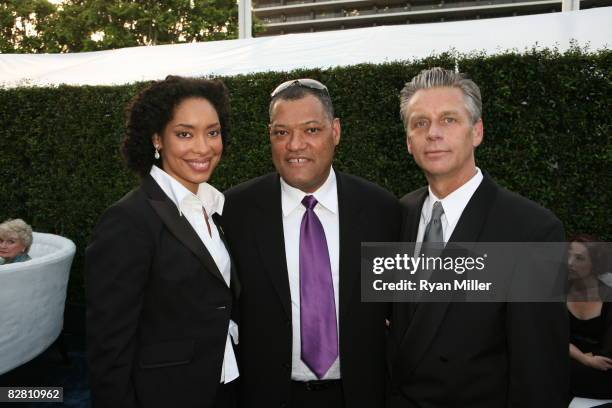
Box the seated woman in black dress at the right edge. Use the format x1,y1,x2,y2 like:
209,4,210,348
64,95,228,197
567,235,612,398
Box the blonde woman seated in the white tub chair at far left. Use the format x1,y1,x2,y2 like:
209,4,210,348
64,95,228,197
0,218,32,265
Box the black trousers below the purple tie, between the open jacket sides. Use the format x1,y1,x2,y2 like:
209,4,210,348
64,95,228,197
289,380,344,408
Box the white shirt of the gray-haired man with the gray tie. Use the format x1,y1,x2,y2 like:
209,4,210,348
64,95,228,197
415,167,483,247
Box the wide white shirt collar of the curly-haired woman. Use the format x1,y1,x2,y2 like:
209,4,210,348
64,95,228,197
150,165,225,216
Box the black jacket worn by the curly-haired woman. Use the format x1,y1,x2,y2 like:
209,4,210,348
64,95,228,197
85,176,239,408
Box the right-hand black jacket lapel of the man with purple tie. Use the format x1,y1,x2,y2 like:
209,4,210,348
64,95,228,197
336,171,367,324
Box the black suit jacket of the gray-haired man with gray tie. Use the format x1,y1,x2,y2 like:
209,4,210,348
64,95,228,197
389,174,569,408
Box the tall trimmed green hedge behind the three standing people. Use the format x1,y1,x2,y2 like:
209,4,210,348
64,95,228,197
0,48,612,302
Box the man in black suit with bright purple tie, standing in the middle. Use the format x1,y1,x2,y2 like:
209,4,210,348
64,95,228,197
224,79,400,408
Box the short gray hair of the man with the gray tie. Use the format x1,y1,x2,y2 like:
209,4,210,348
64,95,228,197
400,67,482,129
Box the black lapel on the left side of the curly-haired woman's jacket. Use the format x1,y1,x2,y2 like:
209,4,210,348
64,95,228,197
142,176,226,285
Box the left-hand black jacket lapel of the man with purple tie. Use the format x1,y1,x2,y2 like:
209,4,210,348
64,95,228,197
254,174,291,318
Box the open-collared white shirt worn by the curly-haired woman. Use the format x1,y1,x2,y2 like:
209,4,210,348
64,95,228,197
151,166,238,383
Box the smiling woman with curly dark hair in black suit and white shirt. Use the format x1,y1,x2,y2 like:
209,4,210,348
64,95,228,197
85,76,239,408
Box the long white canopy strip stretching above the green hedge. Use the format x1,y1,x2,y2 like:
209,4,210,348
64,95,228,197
0,7,612,87
